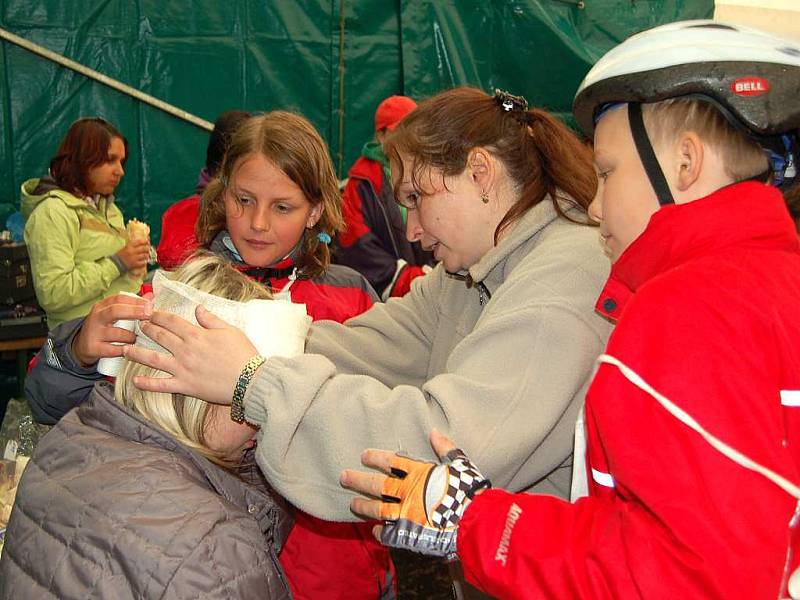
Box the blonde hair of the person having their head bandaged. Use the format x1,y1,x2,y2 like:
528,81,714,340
114,253,271,468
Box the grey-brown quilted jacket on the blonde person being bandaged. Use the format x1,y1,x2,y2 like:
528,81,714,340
0,382,291,600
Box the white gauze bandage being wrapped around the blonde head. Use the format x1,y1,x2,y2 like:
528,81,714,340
97,271,311,377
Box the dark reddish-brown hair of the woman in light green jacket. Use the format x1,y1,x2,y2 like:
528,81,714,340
50,117,128,196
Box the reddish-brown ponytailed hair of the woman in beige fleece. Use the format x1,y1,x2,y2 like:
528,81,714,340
383,87,597,243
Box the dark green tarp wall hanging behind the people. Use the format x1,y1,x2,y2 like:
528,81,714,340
0,0,713,244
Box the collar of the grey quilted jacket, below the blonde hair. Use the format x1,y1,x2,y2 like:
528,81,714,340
75,381,290,549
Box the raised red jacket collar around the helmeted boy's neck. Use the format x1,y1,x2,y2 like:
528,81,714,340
595,181,800,320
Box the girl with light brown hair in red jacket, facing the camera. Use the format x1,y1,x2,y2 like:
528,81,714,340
196,111,395,599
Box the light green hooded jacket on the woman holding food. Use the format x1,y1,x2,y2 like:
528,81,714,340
21,179,142,329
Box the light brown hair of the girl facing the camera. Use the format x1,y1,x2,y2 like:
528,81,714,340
195,111,344,277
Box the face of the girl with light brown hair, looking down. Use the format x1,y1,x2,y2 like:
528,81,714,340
225,154,322,267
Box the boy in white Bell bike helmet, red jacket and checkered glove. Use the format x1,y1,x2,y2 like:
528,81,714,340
342,21,800,598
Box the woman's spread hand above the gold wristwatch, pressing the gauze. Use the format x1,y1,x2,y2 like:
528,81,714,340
124,306,258,404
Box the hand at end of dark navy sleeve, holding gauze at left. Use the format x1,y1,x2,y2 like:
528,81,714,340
72,294,153,367
